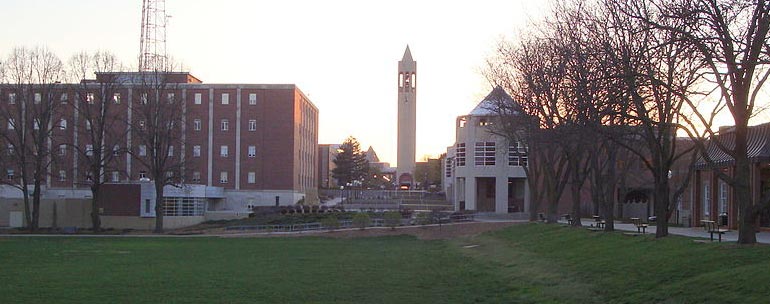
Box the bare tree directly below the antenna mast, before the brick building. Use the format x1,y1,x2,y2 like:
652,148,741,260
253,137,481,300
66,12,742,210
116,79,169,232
129,69,189,233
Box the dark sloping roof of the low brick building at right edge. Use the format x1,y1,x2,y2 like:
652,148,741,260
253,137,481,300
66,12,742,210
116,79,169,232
695,123,770,169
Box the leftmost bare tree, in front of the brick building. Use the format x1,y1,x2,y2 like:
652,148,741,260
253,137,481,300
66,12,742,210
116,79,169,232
0,47,63,231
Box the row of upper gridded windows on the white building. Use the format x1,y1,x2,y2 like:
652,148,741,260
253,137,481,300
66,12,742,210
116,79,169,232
452,141,528,169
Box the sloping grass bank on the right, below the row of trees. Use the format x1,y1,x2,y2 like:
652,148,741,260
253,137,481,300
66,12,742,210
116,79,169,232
457,224,770,303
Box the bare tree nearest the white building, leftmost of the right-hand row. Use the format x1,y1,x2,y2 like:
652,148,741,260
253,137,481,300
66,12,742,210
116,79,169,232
486,35,569,223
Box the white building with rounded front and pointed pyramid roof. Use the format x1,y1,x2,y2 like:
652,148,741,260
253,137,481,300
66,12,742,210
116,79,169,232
443,87,530,213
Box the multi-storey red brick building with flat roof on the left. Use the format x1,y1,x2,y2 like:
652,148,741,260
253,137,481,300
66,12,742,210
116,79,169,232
0,72,318,228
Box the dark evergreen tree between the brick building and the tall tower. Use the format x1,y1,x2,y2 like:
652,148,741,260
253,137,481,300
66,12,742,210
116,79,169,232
332,136,369,185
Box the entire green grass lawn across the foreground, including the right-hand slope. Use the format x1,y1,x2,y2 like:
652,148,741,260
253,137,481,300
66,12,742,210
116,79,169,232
0,224,770,303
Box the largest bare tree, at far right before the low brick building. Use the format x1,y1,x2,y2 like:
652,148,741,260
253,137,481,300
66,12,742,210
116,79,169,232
626,0,770,244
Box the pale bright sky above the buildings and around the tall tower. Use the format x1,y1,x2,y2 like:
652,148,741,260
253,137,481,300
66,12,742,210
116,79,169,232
0,0,547,166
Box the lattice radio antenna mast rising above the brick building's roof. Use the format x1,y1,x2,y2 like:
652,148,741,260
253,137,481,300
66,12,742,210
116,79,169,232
139,0,169,72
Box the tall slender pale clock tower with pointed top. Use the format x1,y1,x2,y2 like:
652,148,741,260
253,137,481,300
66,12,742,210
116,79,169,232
396,45,417,188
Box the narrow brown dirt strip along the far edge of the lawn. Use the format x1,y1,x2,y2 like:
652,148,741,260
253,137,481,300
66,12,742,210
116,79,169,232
222,222,519,240
